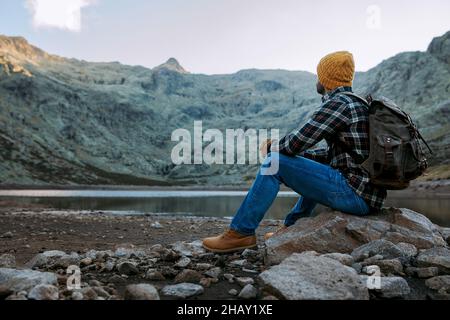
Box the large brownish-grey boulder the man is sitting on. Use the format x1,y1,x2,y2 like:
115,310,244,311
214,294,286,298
266,208,446,264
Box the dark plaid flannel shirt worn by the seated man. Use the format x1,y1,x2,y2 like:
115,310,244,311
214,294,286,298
276,87,386,211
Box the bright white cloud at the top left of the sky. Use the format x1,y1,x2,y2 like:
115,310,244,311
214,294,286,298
26,0,95,32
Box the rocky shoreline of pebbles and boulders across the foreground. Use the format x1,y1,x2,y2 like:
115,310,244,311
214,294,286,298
0,209,450,300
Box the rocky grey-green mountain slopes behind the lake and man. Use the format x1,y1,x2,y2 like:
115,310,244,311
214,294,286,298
0,32,450,185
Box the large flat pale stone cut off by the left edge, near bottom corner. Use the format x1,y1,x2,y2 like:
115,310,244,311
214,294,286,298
0,268,58,292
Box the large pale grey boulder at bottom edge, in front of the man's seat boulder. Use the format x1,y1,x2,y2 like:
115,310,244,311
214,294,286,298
259,252,369,300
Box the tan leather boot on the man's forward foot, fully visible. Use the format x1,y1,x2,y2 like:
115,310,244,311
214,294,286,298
203,229,256,253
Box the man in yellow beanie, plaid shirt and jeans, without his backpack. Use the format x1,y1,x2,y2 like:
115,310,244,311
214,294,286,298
203,51,386,253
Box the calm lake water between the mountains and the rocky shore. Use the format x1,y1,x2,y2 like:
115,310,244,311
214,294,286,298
0,190,450,227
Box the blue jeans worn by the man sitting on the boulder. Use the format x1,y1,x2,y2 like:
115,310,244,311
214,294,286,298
230,153,370,235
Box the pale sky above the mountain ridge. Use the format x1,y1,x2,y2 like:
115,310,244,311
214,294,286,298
0,0,450,74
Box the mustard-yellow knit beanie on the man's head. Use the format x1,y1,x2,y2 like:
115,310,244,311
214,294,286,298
317,51,355,90
